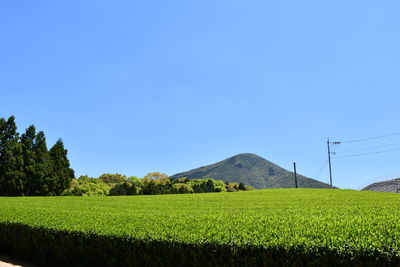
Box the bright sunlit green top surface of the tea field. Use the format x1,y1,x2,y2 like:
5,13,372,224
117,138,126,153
0,189,400,266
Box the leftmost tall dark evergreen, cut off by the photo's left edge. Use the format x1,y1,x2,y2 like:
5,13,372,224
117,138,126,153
0,116,24,196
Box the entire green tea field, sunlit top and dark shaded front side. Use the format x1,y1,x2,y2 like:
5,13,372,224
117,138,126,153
0,189,400,266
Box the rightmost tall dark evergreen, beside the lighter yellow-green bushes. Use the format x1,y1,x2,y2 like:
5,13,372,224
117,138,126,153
50,139,75,195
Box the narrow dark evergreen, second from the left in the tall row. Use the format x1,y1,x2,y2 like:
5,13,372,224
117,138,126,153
20,125,36,196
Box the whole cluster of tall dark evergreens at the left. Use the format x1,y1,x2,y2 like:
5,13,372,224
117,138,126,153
0,116,74,196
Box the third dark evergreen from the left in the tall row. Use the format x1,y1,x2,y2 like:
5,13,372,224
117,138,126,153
31,131,55,196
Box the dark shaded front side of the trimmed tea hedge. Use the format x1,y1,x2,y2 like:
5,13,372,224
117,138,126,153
0,222,400,266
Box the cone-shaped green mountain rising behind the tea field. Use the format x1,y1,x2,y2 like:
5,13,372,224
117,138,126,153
172,153,330,189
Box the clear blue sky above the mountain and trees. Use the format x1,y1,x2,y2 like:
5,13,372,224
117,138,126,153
0,0,400,189
